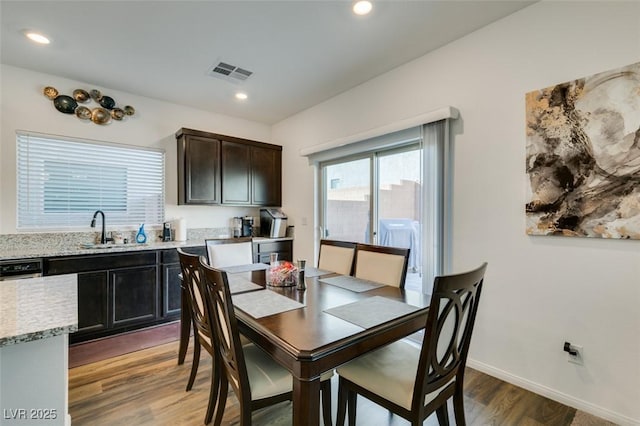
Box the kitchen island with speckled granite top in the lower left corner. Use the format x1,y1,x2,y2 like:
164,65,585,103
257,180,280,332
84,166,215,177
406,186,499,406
0,274,78,426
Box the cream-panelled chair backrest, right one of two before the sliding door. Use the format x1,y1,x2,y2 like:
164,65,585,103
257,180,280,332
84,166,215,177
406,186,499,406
354,243,410,288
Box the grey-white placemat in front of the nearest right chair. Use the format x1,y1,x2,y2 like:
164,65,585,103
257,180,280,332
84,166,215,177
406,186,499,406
324,296,420,328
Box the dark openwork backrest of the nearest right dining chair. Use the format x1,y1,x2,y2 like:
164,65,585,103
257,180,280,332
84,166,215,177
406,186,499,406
412,263,487,408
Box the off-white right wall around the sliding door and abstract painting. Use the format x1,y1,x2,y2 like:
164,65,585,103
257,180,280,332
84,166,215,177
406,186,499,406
272,1,640,424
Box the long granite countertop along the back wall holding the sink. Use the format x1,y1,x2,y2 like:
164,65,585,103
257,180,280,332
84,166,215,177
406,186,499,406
0,237,293,260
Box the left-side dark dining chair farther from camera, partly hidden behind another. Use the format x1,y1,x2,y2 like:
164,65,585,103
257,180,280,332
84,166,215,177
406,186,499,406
176,248,220,424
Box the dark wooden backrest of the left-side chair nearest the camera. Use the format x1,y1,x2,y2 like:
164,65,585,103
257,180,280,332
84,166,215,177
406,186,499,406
200,258,251,406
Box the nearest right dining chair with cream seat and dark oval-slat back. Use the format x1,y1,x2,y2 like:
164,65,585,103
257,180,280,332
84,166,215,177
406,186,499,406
336,263,487,426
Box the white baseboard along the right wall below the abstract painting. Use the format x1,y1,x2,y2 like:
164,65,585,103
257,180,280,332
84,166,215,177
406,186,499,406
467,359,640,426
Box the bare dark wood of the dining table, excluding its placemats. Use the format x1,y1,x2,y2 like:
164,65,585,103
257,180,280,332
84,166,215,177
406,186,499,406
230,271,430,426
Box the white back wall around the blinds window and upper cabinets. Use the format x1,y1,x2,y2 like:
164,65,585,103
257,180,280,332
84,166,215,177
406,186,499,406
0,65,270,234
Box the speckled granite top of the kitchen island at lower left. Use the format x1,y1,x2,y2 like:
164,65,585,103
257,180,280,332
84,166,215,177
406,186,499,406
0,274,78,347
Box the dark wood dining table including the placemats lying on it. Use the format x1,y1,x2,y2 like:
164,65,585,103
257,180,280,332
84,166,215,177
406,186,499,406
228,270,430,426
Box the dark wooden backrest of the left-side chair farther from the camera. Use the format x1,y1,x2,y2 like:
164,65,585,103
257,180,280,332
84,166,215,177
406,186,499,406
176,248,213,354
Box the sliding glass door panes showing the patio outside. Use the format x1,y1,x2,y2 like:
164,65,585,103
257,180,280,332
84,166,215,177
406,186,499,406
321,143,422,290
